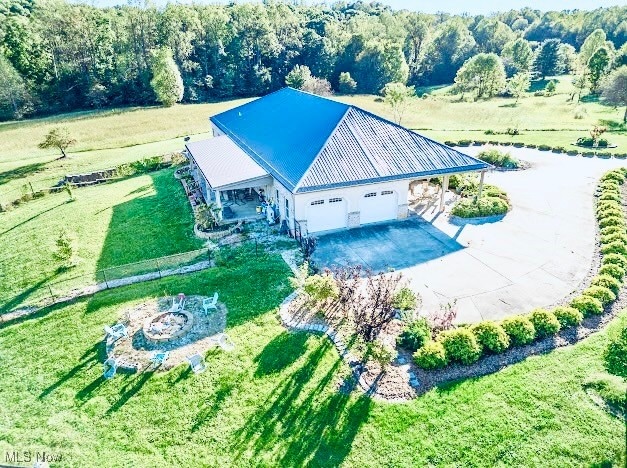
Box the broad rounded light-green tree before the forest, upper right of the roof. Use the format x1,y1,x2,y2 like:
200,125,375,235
455,53,506,98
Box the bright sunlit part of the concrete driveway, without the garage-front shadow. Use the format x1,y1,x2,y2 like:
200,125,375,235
410,147,625,323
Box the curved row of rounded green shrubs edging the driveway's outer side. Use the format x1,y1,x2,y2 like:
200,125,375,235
412,169,627,369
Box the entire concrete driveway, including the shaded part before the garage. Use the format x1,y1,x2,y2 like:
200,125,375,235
314,147,625,323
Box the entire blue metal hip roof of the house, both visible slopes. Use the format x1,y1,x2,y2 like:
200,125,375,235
211,88,491,192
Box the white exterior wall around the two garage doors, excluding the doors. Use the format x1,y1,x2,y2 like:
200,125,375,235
294,180,410,234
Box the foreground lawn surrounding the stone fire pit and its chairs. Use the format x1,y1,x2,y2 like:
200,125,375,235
0,255,625,467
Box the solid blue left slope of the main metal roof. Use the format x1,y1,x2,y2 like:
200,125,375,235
210,88,349,190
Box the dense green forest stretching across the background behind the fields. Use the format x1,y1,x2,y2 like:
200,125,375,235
0,0,627,119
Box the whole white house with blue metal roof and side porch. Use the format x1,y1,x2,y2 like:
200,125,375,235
186,88,491,234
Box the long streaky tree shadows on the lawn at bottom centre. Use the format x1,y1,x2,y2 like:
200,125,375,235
232,339,372,466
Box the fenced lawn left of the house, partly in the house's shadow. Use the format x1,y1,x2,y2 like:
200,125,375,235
0,169,202,312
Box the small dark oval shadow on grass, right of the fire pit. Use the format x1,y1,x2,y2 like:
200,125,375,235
253,331,309,377
